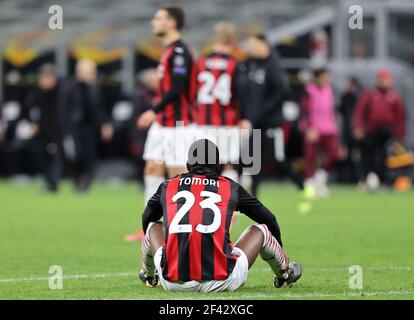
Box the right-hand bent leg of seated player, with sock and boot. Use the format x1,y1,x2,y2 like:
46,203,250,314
235,224,302,288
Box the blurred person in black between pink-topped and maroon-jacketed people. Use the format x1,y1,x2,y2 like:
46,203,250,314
339,77,361,183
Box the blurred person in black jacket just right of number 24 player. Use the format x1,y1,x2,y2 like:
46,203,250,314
241,34,304,196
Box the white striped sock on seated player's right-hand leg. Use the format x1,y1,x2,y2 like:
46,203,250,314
255,224,289,279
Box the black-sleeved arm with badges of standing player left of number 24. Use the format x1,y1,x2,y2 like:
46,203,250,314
152,48,192,112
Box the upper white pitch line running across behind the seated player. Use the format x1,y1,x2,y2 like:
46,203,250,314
0,266,412,283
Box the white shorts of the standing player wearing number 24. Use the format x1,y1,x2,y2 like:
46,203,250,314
197,126,240,164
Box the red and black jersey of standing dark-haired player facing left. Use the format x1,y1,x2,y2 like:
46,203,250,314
154,40,195,127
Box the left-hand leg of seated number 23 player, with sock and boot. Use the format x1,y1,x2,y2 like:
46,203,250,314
139,222,165,287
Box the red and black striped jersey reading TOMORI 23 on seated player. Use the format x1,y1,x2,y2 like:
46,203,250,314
142,170,281,282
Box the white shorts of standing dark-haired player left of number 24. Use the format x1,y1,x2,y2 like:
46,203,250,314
143,122,196,168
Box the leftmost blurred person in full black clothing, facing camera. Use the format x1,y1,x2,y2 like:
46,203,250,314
27,64,64,192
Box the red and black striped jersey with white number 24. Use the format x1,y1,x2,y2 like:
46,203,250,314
196,52,240,126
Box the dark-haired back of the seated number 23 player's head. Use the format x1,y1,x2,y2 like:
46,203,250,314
187,139,220,172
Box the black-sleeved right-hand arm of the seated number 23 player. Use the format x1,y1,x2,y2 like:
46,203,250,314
235,185,283,247
